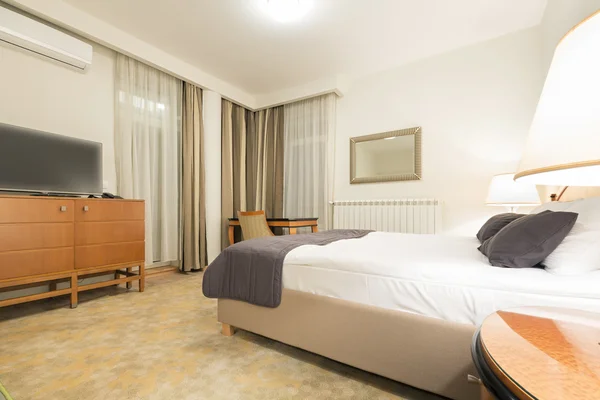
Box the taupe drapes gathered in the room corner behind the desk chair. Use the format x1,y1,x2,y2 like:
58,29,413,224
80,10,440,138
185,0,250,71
221,100,284,248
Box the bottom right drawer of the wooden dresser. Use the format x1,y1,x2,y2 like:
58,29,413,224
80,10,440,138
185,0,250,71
75,242,146,268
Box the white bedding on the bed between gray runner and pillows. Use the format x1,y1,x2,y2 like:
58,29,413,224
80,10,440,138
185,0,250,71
283,232,600,325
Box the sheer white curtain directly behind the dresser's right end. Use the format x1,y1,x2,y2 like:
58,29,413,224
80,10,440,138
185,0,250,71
115,54,182,264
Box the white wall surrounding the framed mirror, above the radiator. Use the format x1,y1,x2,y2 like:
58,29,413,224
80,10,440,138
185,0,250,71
335,28,543,235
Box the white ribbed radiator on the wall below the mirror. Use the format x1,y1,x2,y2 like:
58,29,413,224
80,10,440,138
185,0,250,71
331,199,442,233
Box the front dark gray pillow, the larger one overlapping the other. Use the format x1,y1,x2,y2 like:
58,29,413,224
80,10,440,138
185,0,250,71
479,211,577,268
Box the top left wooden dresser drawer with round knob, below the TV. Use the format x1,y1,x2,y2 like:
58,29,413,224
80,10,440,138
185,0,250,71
0,197,75,224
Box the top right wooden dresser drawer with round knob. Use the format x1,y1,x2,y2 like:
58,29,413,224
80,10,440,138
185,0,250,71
75,199,144,222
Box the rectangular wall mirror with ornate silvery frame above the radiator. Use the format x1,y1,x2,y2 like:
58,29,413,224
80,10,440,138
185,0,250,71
350,127,421,183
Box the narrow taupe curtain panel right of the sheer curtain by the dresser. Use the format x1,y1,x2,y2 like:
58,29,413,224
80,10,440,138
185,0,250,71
180,82,206,272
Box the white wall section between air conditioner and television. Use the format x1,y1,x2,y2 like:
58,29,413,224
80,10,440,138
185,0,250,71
0,38,116,191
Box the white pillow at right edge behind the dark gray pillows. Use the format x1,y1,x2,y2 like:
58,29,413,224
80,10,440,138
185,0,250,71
542,197,600,275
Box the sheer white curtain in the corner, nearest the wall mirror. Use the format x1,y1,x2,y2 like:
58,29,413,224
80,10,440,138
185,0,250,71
283,93,337,230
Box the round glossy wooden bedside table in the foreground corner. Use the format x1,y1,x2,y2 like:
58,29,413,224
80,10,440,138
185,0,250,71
471,307,600,400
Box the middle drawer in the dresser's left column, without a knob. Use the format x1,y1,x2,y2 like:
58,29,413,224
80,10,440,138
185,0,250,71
0,222,74,252
